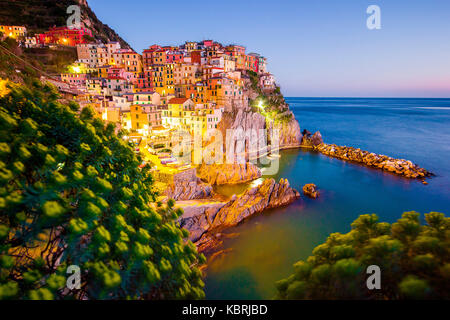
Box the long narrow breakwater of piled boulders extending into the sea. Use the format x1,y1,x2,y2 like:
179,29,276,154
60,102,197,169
314,143,432,179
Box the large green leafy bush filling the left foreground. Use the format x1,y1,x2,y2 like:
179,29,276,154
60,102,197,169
0,83,204,299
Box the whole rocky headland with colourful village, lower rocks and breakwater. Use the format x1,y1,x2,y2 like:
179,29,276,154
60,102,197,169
0,21,431,258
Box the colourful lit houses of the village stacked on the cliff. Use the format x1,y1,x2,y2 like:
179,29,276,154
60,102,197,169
0,26,286,182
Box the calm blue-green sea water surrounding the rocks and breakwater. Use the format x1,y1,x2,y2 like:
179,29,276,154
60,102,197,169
205,98,450,299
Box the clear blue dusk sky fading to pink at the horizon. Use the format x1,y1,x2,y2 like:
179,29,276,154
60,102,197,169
88,0,450,98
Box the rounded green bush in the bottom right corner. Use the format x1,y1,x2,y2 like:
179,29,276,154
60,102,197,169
276,211,450,299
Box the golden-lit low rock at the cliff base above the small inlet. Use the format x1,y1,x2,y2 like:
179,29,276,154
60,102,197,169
197,162,261,185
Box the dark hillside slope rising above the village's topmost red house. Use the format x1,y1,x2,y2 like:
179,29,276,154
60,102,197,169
0,0,130,48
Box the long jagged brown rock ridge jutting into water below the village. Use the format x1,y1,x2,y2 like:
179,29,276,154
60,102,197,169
179,179,300,251
